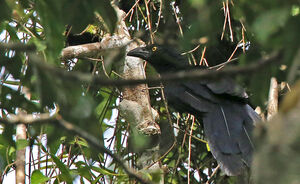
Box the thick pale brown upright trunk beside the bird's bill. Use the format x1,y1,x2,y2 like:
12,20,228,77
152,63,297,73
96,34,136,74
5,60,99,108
113,6,160,135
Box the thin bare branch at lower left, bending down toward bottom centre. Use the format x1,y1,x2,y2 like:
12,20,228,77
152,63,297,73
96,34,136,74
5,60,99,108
0,113,152,184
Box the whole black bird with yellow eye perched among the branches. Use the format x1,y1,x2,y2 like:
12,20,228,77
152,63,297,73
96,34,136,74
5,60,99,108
127,44,260,176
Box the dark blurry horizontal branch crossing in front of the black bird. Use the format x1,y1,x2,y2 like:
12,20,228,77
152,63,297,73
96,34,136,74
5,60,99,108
29,52,281,87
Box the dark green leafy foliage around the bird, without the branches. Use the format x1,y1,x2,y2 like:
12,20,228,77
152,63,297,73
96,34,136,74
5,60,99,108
0,0,300,183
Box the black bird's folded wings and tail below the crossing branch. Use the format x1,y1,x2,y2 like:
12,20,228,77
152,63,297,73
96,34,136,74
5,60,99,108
165,82,259,175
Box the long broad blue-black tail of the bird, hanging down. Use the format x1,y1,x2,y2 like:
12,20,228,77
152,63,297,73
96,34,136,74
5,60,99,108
203,102,259,176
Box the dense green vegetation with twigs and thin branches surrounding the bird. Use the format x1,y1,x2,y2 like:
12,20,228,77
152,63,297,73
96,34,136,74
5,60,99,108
0,0,300,183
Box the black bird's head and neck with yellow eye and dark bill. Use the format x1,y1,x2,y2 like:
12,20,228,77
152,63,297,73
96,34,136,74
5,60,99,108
127,44,188,73
